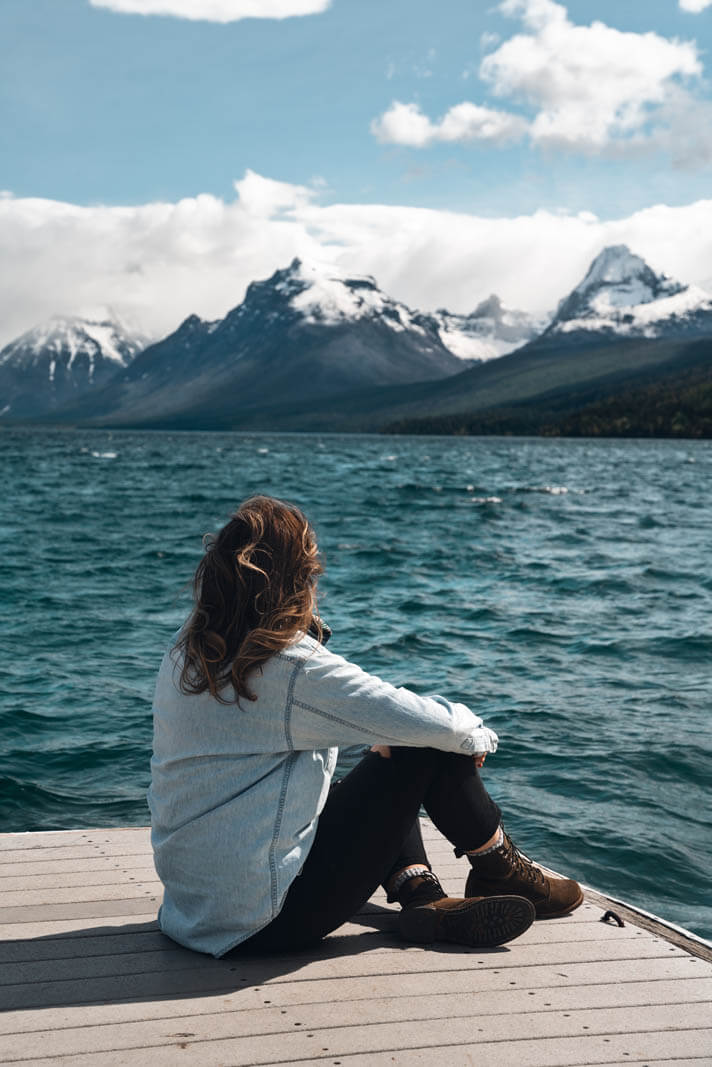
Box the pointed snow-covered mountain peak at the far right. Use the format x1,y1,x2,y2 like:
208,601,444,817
544,244,712,343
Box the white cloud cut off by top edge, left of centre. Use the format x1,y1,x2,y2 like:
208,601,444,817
90,0,331,22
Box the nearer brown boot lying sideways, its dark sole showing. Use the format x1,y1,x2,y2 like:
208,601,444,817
398,896,536,949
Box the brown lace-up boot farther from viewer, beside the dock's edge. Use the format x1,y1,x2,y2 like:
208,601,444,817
464,831,584,919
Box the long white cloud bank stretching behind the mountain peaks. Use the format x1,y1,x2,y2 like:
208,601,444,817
0,172,712,345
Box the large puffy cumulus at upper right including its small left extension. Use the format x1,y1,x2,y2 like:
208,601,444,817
371,0,712,158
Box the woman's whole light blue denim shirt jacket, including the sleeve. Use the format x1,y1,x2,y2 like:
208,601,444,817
148,636,497,956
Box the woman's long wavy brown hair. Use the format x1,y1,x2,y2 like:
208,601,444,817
176,496,322,703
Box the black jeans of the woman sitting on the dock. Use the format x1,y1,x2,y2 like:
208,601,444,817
236,748,501,952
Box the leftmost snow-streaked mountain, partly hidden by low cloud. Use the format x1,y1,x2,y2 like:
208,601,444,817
0,316,145,417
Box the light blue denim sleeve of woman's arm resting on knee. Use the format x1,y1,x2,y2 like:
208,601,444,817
281,638,497,755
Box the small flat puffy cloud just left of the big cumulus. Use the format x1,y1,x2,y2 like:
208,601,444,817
370,100,526,148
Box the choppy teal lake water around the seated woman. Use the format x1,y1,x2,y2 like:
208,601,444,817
0,431,712,937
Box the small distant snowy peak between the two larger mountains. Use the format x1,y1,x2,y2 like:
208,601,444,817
430,293,550,361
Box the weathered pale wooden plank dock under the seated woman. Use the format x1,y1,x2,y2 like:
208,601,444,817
0,823,712,1067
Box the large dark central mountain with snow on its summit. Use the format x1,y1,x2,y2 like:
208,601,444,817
59,259,462,425
